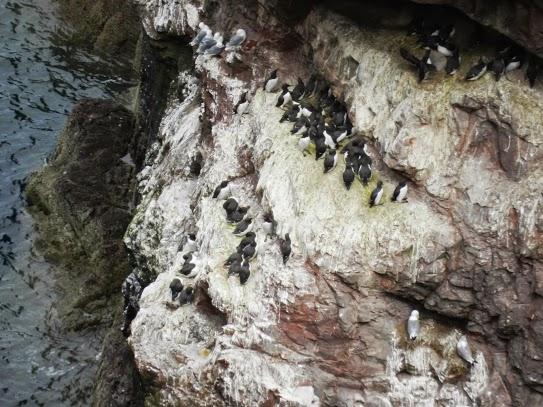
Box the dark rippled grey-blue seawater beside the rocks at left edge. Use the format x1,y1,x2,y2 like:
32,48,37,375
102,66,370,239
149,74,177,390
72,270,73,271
0,0,134,406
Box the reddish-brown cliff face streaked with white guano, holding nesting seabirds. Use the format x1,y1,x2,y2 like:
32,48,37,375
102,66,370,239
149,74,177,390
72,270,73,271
125,0,543,406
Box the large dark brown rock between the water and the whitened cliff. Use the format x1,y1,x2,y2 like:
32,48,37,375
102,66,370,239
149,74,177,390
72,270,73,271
27,100,142,406
